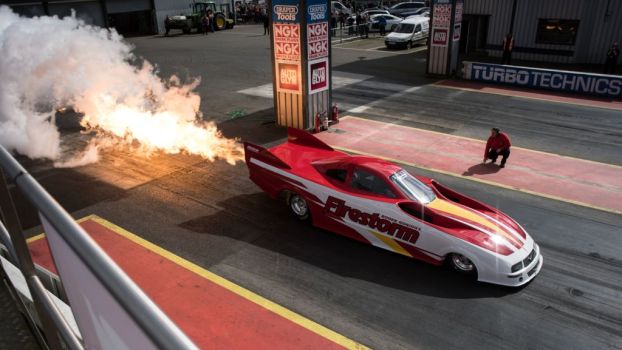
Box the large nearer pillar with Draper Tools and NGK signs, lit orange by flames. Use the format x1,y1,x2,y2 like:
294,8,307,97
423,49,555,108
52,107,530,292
269,0,331,130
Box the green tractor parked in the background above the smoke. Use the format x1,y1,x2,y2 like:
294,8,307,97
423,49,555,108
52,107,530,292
168,1,234,34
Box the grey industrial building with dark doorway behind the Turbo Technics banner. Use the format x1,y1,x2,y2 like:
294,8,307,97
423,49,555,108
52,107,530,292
460,0,622,64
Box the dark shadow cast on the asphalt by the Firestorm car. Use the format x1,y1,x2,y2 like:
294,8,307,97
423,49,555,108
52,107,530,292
180,193,516,299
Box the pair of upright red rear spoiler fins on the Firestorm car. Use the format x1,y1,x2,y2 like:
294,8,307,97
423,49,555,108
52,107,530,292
244,128,334,169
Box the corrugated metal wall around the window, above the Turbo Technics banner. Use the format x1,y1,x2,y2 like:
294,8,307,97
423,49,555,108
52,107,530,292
464,0,622,64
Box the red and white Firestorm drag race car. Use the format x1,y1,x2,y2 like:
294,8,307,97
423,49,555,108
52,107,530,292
244,128,543,286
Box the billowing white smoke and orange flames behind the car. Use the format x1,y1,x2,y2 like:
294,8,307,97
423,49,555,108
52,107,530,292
0,6,242,166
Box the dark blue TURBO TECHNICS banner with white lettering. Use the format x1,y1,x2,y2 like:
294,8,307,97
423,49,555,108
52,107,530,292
464,62,622,98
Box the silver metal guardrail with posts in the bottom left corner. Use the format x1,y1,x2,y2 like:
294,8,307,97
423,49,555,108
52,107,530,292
0,146,197,350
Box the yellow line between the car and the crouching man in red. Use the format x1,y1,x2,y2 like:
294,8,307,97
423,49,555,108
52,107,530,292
330,145,622,215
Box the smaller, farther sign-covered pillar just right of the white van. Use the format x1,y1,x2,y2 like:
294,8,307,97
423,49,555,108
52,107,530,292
426,0,463,77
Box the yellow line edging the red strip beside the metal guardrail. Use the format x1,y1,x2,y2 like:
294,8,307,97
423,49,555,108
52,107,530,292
69,215,369,350
